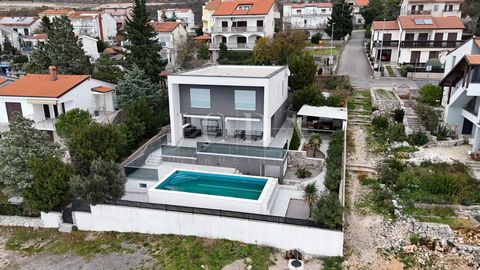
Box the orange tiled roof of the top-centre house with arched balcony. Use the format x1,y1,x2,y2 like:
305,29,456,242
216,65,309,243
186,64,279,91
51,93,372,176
213,0,275,16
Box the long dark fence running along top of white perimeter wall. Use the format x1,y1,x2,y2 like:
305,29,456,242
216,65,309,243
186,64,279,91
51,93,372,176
104,200,341,231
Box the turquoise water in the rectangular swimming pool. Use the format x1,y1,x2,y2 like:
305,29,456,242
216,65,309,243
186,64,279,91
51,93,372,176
156,170,267,200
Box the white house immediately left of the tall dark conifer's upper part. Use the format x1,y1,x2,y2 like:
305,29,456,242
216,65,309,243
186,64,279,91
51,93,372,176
68,11,117,42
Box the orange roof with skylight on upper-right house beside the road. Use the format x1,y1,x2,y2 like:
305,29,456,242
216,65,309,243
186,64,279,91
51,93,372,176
398,15,465,29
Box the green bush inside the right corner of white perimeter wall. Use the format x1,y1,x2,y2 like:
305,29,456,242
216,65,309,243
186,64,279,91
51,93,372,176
312,192,343,230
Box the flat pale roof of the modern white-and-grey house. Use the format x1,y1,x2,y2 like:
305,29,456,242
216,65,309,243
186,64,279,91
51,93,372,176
176,65,287,78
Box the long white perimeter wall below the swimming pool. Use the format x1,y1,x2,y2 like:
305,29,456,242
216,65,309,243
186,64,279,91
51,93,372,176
73,205,343,256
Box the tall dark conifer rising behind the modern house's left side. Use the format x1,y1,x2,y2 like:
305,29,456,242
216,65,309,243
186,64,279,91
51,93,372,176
125,0,166,82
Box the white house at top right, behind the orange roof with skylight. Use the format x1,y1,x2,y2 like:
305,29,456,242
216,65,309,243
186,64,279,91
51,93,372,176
400,0,464,17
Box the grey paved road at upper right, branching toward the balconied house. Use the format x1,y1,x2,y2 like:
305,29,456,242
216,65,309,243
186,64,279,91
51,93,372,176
337,31,423,89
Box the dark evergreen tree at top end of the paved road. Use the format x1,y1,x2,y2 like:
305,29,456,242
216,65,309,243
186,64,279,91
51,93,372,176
325,0,353,40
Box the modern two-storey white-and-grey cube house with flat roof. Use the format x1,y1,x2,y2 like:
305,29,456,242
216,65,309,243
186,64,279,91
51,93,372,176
168,65,290,147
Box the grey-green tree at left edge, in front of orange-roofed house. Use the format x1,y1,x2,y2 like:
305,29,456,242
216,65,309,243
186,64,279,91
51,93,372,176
0,112,61,197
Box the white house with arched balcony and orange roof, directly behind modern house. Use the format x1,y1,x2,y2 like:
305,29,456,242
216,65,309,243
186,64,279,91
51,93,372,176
210,0,280,56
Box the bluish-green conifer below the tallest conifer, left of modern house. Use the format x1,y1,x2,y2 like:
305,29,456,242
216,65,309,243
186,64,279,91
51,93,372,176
117,64,160,108
